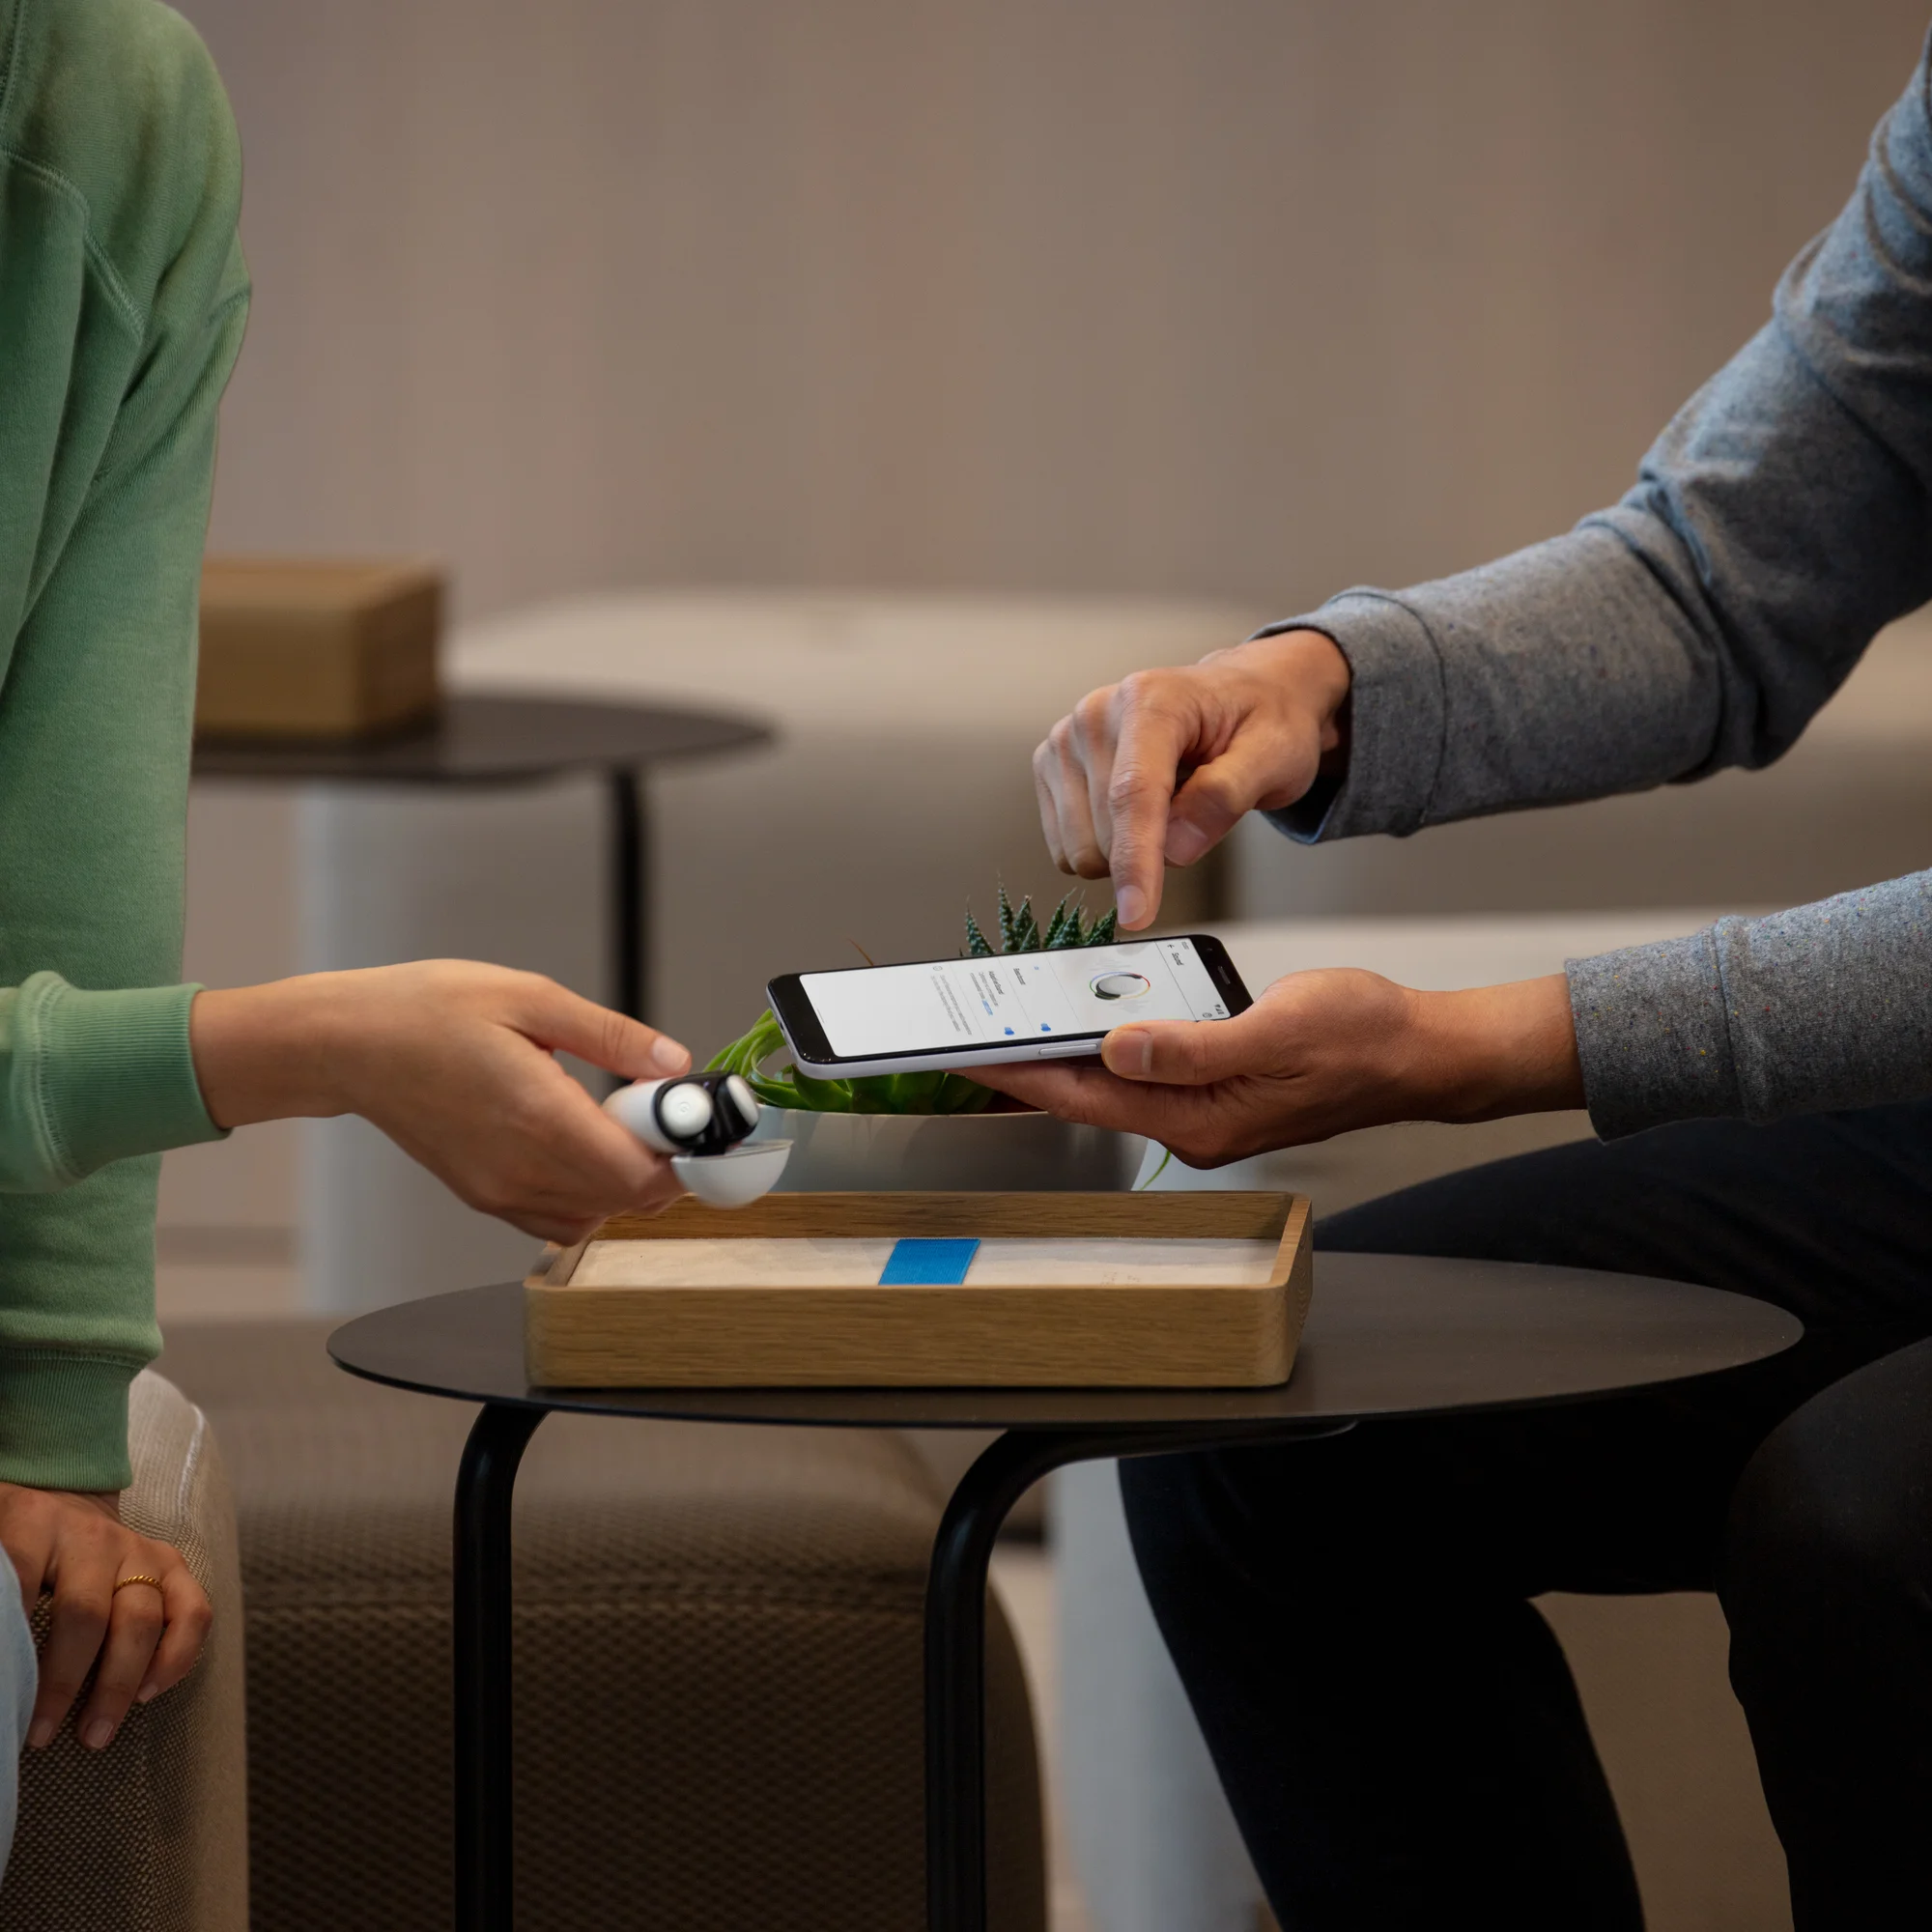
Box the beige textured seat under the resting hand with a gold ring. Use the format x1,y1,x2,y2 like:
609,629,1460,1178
0,1374,249,1932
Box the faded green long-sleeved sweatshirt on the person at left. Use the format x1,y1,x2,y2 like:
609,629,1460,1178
0,0,247,1490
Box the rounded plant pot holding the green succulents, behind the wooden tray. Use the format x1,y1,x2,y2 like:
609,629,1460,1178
752,1107,1148,1194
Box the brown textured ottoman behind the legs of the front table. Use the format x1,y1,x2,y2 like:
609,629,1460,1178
166,1321,1045,1932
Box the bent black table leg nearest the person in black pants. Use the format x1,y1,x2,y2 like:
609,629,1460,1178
925,1422,1354,1932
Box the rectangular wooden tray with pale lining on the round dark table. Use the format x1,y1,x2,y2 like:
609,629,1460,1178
526,1192,1314,1389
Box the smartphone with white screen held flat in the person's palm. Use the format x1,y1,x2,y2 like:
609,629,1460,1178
765,933,1254,1080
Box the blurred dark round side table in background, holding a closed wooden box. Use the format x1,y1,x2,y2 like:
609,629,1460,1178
193,696,773,1020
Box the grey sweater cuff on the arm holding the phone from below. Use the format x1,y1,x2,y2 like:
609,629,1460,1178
1563,931,1745,1140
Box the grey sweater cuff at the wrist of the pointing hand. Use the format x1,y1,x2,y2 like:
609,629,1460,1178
1256,591,1449,844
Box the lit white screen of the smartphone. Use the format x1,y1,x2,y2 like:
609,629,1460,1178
800,939,1227,1061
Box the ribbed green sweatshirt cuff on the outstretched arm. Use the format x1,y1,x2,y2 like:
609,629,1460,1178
32,974,222,1180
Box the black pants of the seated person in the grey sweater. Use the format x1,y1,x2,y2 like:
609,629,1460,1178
1121,1103,1932,1932
